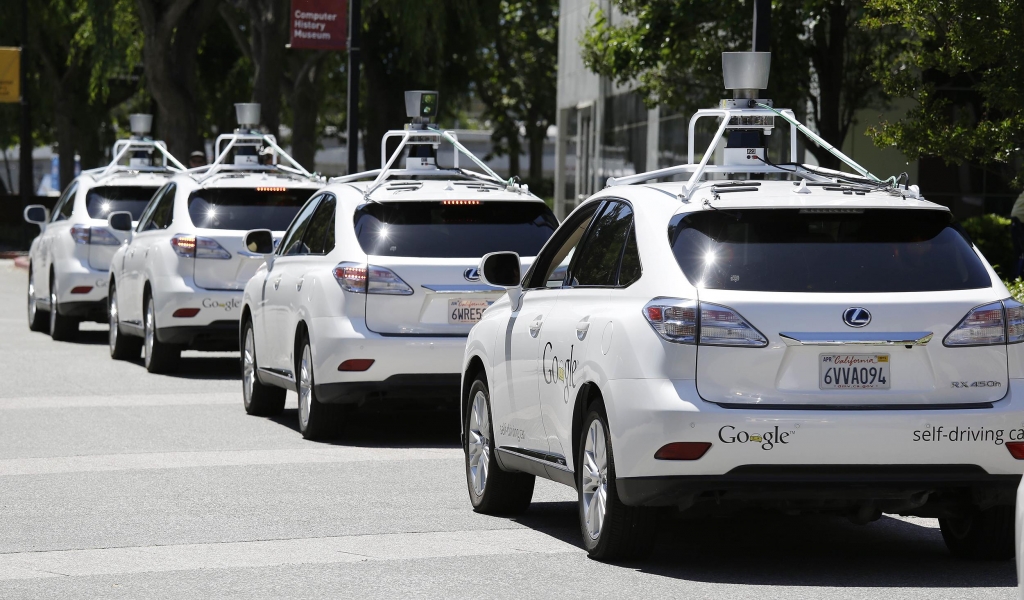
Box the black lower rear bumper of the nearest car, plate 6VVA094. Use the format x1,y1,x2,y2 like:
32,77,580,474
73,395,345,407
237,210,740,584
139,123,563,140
615,464,1021,509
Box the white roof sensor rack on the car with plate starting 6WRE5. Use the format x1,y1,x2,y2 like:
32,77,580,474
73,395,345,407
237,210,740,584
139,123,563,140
331,90,529,200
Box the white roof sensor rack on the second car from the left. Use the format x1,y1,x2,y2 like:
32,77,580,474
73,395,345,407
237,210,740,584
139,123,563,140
188,102,324,181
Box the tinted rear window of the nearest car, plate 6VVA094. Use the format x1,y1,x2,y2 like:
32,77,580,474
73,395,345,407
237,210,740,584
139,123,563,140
669,209,992,293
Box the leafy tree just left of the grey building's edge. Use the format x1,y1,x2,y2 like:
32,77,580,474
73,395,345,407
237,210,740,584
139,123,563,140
475,0,558,188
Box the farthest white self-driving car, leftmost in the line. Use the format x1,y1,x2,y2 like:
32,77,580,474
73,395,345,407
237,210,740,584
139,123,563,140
25,115,185,340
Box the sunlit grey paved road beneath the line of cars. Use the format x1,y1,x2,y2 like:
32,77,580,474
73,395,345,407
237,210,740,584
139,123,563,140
0,261,1016,600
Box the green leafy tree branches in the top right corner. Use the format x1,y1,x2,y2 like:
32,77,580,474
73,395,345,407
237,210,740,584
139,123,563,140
865,0,1024,186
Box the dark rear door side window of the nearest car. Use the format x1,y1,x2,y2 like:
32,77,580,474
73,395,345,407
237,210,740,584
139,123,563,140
569,202,633,287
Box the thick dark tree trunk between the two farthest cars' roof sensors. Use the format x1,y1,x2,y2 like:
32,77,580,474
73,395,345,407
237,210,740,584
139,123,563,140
135,0,220,157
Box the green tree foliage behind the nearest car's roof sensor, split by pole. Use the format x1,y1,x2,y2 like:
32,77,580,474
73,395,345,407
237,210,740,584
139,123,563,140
583,0,894,168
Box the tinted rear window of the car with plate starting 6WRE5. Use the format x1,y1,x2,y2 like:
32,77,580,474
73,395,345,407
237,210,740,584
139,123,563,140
355,201,558,258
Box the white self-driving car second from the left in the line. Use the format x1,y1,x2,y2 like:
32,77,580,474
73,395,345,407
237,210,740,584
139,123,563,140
108,104,323,373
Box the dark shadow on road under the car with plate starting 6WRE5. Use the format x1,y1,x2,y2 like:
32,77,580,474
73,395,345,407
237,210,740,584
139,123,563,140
270,401,460,447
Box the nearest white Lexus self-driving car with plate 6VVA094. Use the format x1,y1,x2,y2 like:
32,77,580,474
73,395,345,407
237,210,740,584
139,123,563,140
462,51,1024,559
